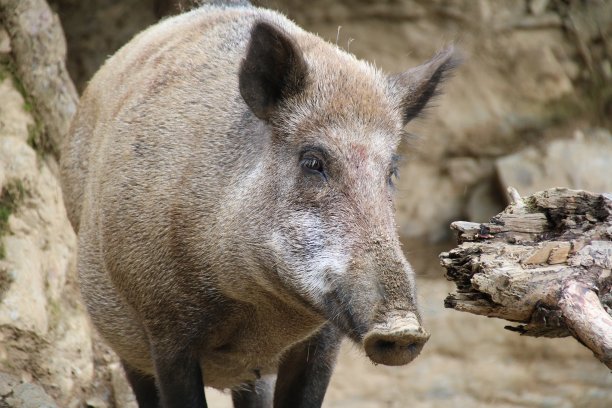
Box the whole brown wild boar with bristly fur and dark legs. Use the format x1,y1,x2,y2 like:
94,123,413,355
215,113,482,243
61,1,457,408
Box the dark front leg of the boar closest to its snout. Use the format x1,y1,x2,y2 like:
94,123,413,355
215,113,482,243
274,323,342,408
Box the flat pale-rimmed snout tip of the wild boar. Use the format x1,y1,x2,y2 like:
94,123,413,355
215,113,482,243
363,312,429,366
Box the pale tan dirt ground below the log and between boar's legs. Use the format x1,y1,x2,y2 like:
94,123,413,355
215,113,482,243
207,243,612,408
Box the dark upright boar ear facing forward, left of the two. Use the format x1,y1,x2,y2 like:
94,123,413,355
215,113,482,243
239,22,308,120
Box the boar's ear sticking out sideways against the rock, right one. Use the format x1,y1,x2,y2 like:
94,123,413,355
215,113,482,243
388,47,461,125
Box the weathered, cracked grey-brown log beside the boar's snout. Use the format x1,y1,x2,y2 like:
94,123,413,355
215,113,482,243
440,188,612,368
